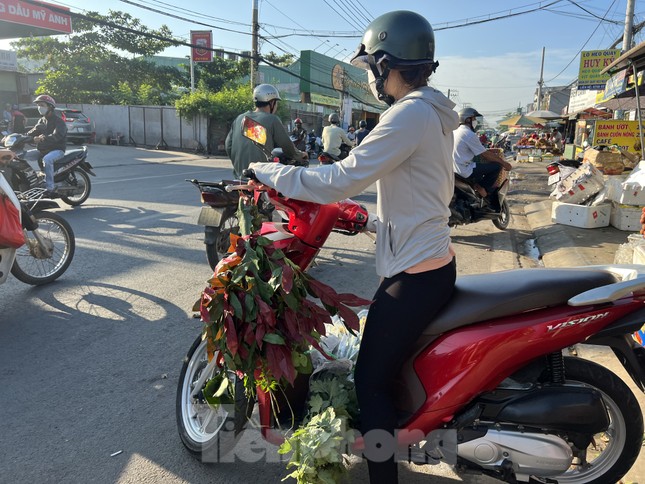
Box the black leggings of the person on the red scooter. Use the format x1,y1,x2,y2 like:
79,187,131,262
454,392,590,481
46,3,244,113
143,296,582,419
355,259,457,484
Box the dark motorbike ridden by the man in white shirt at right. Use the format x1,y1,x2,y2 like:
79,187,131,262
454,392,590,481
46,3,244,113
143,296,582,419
448,169,511,230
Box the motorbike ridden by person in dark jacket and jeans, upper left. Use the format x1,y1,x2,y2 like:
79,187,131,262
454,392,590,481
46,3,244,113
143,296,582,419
3,133,96,207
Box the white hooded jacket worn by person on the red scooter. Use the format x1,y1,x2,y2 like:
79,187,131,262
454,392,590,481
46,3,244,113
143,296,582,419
251,87,459,277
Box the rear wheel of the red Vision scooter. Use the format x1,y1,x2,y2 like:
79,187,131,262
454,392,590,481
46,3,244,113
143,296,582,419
538,357,643,484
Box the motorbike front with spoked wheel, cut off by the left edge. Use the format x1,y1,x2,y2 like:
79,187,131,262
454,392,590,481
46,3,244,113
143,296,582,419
0,173,76,286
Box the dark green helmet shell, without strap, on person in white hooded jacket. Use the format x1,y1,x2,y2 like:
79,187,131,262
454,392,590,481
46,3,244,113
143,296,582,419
351,10,434,67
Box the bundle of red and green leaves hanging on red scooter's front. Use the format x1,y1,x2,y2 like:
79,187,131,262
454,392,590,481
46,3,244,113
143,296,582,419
196,197,371,398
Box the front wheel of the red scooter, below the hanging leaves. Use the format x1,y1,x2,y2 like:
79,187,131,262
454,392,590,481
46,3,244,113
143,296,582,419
176,336,253,463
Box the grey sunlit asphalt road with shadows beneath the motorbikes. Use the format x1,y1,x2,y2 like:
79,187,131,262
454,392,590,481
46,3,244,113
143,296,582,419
0,146,640,484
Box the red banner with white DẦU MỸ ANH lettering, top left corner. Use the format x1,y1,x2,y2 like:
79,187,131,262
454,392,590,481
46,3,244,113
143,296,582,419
0,0,72,34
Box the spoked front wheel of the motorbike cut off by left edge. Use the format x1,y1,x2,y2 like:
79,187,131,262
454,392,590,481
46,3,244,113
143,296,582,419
11,211,76,286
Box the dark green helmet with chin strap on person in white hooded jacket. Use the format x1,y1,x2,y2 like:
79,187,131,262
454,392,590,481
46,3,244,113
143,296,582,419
351,10,439,104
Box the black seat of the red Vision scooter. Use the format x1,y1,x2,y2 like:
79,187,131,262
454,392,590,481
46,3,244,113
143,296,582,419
423,268,619,335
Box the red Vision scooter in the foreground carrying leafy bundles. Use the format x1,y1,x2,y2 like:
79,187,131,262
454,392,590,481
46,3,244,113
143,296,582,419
177,118,645,484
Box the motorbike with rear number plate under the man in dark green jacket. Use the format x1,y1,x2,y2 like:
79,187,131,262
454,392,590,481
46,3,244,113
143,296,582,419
187,148,309,269
